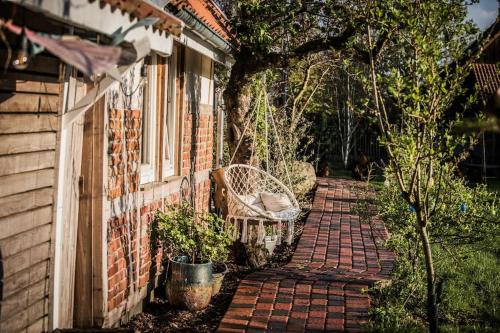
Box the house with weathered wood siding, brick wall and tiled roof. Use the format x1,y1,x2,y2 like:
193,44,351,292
0,0,234,332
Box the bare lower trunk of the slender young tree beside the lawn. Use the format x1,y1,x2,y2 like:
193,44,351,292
417,221,438,333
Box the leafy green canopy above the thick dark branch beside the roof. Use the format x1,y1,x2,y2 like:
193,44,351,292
225,0,356,54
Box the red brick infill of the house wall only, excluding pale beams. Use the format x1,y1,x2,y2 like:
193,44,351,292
107,105,213,311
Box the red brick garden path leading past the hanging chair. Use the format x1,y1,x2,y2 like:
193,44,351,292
218,178,393,332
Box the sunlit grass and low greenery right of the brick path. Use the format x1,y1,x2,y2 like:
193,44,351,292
372,173,500,332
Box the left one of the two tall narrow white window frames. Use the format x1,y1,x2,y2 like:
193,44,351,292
141,54,157,184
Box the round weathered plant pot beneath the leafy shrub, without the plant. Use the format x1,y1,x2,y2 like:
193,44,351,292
166,256,212,311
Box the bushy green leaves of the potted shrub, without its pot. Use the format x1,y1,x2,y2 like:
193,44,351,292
155,203,232,263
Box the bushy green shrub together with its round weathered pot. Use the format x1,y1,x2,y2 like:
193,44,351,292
156,204,230,310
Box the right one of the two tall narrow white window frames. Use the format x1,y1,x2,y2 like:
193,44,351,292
162,50,178,178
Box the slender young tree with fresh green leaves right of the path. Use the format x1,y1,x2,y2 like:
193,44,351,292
358,0,494,332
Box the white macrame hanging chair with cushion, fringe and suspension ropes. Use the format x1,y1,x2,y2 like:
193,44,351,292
223,87,301,244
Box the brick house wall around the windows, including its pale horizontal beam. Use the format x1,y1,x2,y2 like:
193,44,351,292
106,55,213,326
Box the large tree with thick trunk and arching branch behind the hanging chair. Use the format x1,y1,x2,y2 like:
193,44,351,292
219,0,372,163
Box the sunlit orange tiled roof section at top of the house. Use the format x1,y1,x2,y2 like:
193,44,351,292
170,0,235,42
